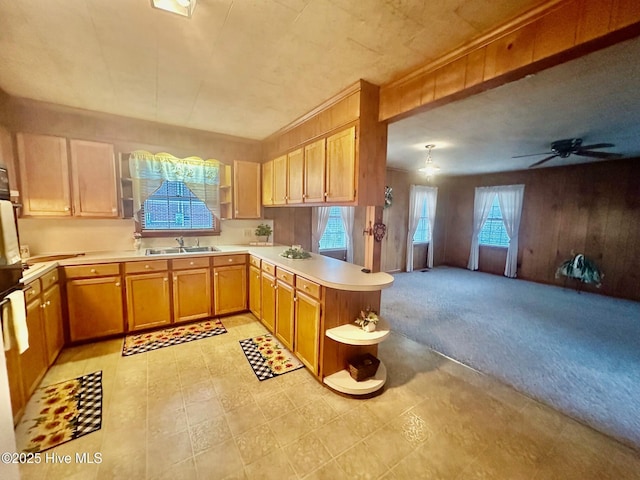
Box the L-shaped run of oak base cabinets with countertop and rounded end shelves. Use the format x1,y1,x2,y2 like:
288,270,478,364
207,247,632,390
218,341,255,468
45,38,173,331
24,245,393,404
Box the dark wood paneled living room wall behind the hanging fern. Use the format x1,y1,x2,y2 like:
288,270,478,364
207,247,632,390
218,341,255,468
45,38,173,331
436,159,640,300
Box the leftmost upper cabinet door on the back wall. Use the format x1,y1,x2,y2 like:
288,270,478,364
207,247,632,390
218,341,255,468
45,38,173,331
17,133,71,216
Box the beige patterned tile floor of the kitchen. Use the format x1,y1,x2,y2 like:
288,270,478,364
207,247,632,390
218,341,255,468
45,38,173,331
16,315,640,480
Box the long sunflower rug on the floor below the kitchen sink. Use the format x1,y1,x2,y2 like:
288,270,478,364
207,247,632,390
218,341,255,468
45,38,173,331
122,318,227,357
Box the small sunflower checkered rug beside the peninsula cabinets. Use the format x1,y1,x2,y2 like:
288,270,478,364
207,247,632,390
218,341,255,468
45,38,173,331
240,334,303,381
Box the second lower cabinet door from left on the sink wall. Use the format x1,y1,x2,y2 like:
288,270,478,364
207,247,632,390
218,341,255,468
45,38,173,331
126,272,171,331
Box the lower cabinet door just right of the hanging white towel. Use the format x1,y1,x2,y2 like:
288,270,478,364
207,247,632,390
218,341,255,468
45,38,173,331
20,298,49,399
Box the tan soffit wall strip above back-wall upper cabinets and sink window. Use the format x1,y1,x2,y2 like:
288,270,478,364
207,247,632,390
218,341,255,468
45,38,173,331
0,98,262,164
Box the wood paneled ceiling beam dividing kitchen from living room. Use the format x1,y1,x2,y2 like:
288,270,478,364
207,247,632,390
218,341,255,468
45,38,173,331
379,0,640,122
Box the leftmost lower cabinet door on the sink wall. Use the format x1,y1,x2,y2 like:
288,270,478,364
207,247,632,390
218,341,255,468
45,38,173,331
67,277,126,342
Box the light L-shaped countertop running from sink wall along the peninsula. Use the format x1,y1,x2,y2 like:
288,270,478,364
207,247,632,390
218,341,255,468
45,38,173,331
23,245,393,291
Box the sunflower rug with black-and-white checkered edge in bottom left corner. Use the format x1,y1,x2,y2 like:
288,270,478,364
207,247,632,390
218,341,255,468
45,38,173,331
16,371,102,453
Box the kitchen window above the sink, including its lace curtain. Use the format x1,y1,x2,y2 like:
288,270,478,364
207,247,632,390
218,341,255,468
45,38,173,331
129,151,220,236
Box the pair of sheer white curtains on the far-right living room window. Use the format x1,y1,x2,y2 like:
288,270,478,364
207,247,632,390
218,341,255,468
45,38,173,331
467,185,524,278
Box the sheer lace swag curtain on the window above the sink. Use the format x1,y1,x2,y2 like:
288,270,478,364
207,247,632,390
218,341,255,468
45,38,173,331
129,150,220,221
